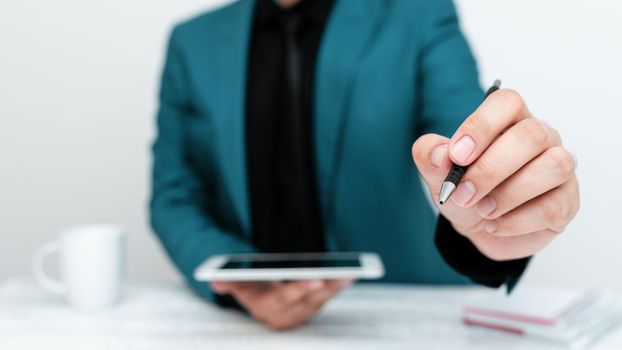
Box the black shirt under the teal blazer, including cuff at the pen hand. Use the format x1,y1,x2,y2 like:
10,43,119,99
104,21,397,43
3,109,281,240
246,0,528,287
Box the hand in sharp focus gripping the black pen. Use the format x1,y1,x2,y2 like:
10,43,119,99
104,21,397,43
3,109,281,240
412,89,579,260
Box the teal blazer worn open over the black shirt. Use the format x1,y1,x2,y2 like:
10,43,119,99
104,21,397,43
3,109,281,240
150,0,483,299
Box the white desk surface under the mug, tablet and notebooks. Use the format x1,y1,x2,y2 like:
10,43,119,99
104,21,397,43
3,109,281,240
0,280,622,350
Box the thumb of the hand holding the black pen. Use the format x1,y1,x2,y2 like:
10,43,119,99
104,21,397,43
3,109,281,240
412,134,451,199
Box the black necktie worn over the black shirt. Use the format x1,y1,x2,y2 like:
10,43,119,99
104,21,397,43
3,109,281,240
264,11,324,252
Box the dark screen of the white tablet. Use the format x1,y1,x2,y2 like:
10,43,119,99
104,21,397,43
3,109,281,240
221,259,361,269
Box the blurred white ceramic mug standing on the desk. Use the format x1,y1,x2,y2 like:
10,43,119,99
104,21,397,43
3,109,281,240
32,224,126,308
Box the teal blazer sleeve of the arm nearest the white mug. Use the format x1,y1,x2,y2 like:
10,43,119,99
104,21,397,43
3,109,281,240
150,29,254,301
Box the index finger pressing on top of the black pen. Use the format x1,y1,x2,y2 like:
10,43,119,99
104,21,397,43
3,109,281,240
449,89,531,166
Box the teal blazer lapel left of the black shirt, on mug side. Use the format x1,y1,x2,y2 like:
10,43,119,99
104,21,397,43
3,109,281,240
212,0,255,234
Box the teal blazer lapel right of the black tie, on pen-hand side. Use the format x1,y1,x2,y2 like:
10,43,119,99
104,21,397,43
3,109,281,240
314,0,383,220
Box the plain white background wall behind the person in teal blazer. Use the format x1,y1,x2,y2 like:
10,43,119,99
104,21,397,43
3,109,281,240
0,0,622,291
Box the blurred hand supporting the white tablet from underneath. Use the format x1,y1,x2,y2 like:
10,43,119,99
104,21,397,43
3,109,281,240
212,279,352,329
